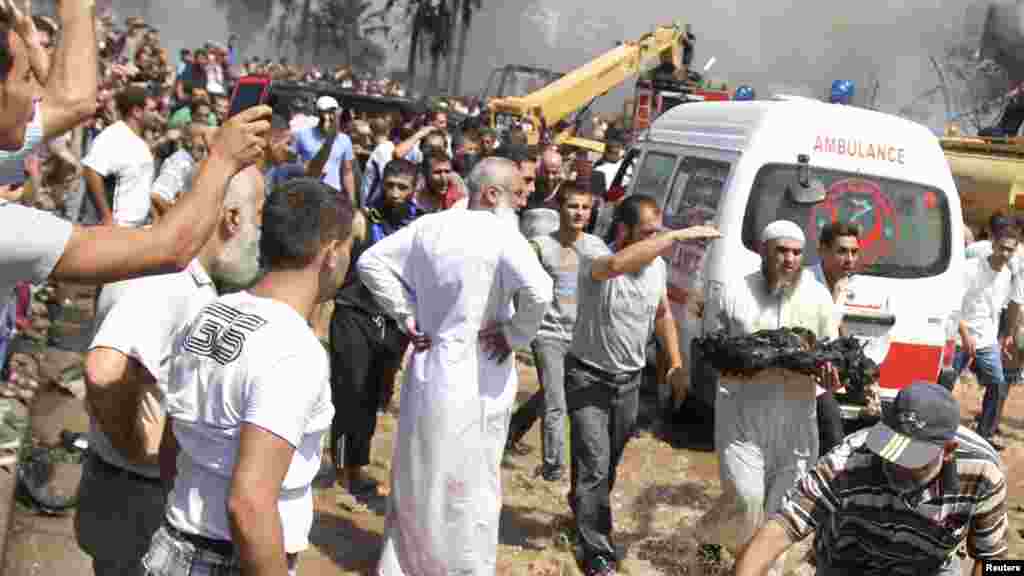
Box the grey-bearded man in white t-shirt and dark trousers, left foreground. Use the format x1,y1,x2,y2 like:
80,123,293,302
75,163,265,576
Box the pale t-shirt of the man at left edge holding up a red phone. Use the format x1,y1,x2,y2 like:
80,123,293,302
0,200,72,310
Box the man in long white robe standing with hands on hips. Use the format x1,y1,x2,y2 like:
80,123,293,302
358,158,553,576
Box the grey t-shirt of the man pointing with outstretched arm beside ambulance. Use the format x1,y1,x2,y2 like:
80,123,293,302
570,250,668,374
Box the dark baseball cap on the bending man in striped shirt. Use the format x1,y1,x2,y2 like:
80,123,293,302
865,381,959,468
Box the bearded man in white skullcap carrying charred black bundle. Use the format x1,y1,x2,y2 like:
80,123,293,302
697,220,839,574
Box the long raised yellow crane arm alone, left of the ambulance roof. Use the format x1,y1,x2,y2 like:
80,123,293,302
490,23,686,129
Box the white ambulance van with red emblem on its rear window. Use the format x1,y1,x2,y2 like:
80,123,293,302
610,97,964,419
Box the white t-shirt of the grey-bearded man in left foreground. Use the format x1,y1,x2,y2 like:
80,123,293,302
89,260,217,478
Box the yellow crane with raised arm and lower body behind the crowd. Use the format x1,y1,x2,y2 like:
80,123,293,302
488,23,689,153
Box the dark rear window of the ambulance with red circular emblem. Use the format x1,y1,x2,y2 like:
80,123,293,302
743,164,952,278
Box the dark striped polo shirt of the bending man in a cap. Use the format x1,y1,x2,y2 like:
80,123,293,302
774,426,1008,576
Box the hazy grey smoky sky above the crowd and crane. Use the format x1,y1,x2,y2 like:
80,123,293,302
113,0,1012,128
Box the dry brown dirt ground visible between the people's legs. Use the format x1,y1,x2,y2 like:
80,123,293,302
2,319,1024,576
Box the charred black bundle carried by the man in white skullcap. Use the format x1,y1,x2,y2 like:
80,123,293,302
696,328,879,404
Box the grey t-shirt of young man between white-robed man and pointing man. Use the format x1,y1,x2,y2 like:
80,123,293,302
529,233,608,343
